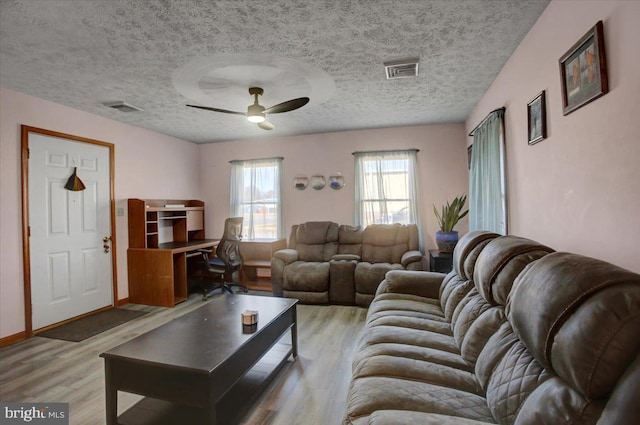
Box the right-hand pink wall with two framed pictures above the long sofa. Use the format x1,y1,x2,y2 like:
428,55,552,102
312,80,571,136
466,0,640,272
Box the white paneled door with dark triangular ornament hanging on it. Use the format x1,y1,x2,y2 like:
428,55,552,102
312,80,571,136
28,132,113,330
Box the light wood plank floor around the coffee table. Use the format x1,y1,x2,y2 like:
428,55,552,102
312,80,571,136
0,296,366,425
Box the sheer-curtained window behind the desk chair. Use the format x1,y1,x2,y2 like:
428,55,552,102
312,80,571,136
231,158,284,239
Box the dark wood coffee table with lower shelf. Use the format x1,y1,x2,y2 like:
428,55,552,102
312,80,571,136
100,294,298,425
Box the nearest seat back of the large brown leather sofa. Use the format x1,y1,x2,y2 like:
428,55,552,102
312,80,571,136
476,253,640,425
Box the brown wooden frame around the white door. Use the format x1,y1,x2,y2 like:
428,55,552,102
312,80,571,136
20,124,118,338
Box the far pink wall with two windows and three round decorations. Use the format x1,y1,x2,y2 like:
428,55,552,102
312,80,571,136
200,124,468,249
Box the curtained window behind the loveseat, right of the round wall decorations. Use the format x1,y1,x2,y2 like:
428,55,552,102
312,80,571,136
354,150,420,226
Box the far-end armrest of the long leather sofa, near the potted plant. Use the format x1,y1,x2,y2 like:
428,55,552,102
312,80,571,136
377,270,446,300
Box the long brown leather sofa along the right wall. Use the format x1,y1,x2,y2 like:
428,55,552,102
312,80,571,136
344,232,640,425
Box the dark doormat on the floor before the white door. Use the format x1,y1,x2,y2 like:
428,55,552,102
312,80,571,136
36,308,147,342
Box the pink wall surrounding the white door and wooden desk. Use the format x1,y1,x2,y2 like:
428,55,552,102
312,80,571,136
0,89,200,338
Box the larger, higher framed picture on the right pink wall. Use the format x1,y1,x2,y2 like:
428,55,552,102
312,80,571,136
560,21,609,115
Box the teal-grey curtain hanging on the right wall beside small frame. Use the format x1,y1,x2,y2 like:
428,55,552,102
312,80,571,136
469,109,507,235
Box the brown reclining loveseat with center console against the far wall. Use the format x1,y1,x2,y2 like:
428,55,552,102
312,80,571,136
271,221,422,306
